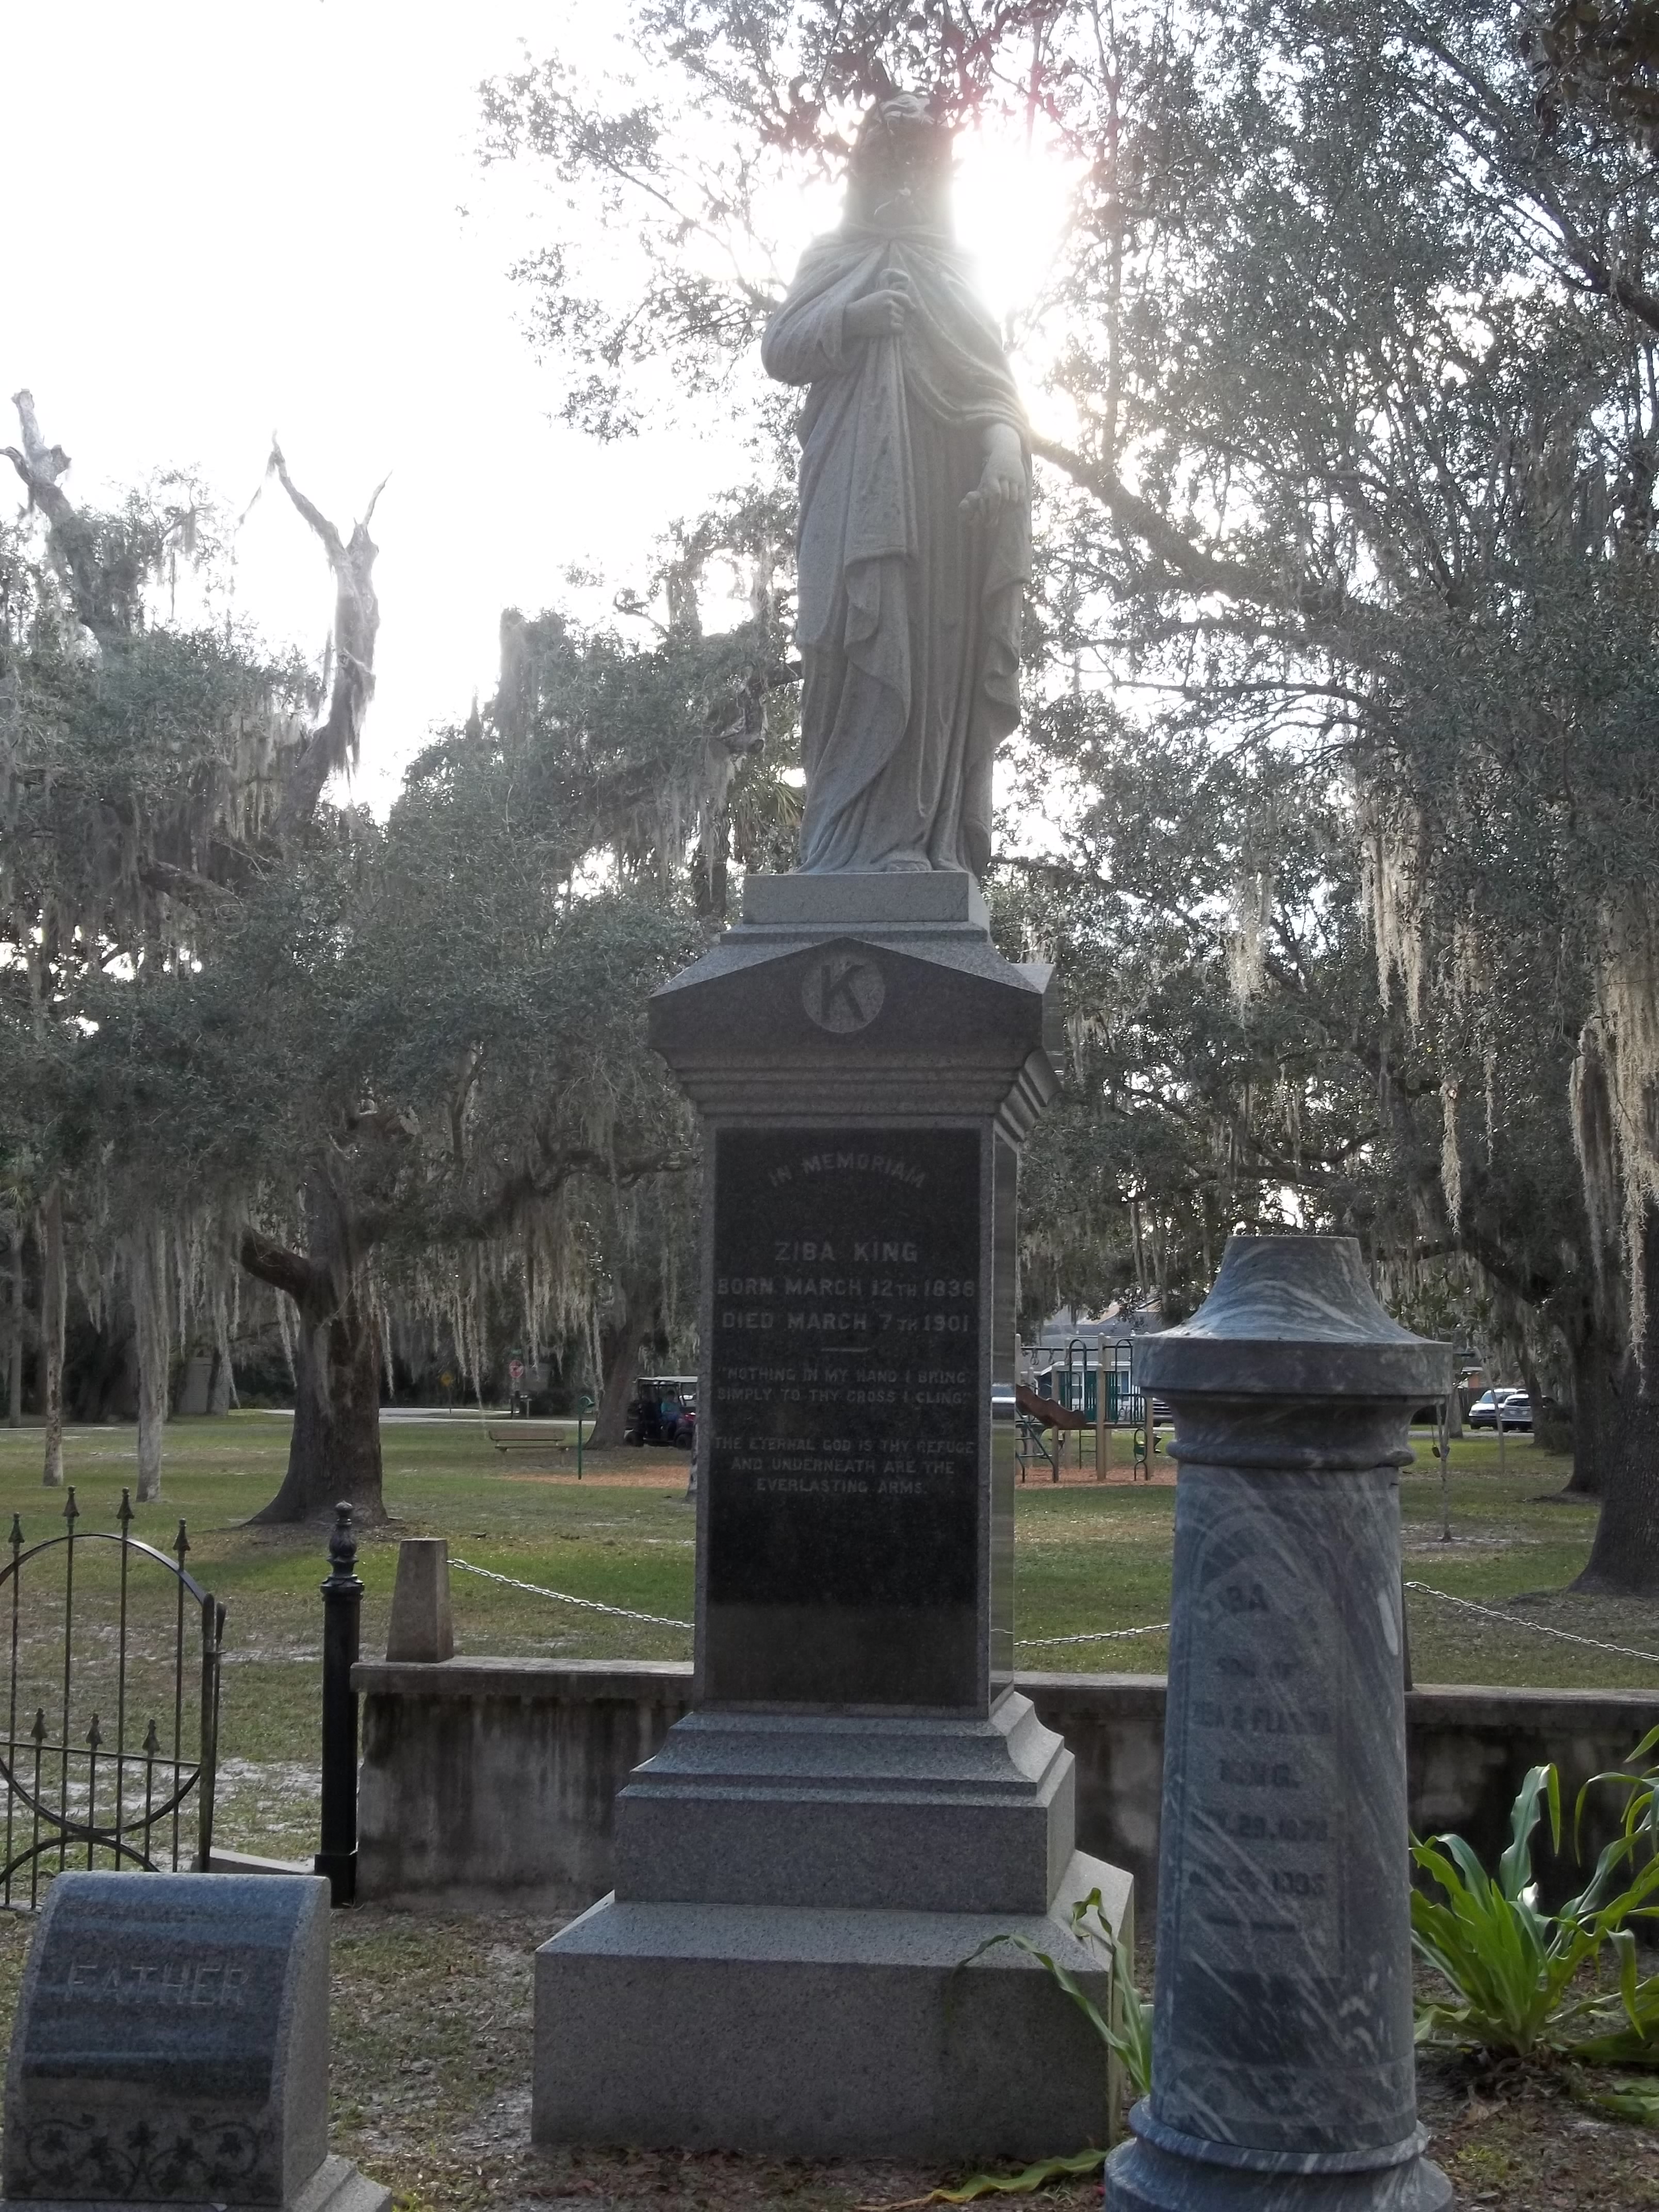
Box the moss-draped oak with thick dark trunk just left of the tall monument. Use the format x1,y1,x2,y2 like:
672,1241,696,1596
82,553,788,1520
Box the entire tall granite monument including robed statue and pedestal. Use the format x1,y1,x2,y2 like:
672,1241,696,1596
533,97,1130,2157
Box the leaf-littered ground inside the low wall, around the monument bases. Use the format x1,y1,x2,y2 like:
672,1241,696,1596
0,1907,1659,2212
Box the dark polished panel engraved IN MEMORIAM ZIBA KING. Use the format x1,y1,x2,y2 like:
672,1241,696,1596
706,1128,989,1705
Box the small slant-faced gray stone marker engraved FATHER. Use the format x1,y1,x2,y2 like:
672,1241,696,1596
0,1874,392,2212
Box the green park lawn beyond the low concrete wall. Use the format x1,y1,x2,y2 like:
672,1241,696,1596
0,1413,1659,1853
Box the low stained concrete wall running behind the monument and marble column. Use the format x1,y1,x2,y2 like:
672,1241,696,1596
352,1659,1659,1913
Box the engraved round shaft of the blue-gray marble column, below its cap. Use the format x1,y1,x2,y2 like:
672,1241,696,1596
1154,1469,1413,2150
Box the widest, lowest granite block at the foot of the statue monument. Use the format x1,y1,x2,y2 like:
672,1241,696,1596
531,1851,1130,2161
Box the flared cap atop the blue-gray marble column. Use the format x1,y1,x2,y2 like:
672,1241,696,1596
1135,1237,1456,1403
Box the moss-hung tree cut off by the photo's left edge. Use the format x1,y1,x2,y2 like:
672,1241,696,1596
0,392,307,1498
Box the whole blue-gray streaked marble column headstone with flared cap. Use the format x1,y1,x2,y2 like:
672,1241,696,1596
1106,1237,1451,2212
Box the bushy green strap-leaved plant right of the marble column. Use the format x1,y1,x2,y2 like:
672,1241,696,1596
1411,1732,1659,2066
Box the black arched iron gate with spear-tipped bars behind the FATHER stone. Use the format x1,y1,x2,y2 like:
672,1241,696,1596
0,1489,225,1911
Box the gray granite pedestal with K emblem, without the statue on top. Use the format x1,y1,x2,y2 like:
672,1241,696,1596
533,874,1130,2157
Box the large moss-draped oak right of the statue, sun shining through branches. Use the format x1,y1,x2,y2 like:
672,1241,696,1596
489,0,1659,1590
